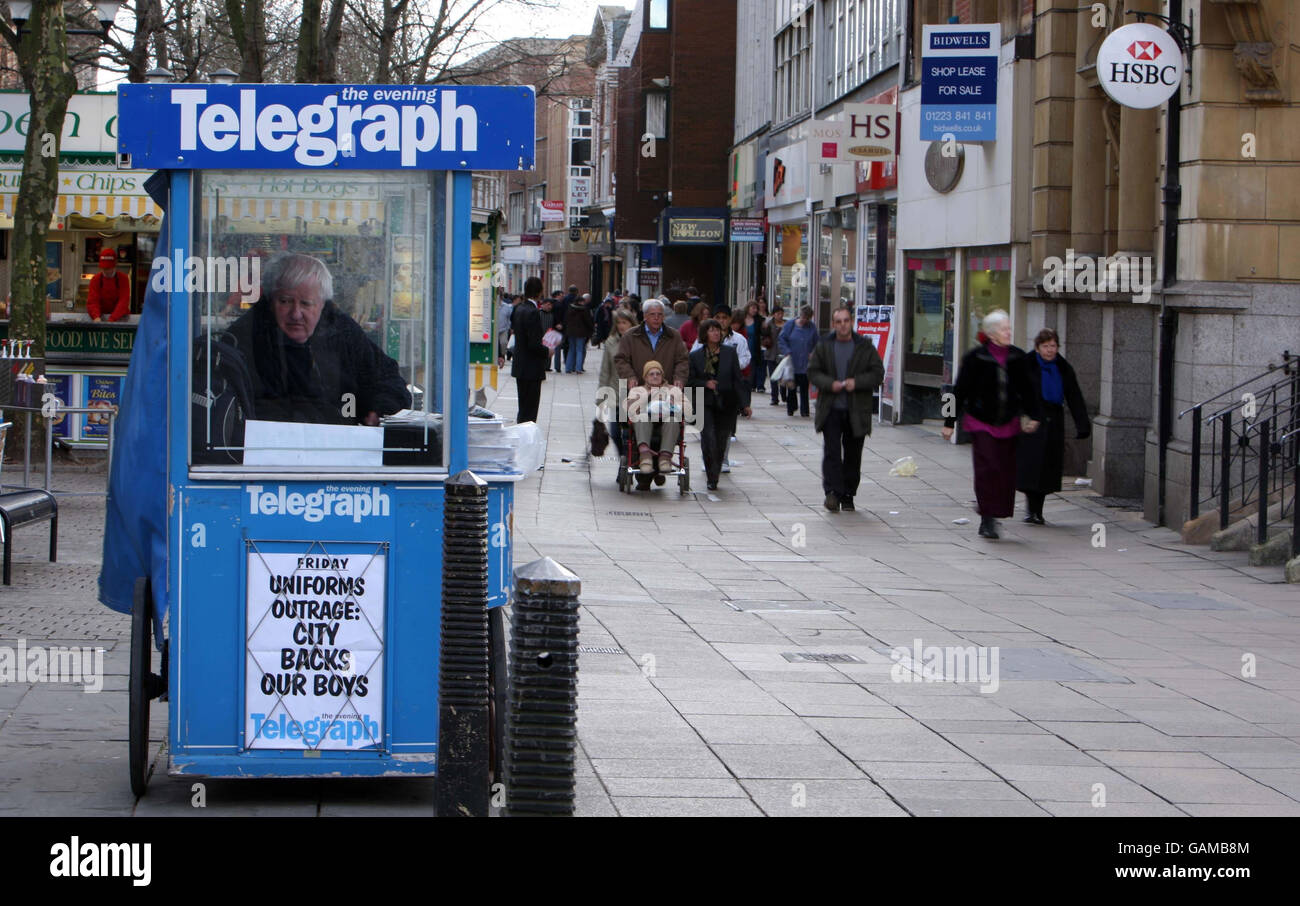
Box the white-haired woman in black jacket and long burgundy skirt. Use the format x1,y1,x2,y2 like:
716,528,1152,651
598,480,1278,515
944,309,1041,538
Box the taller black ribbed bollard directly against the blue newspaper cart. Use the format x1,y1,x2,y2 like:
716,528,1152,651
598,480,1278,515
434,469,490,818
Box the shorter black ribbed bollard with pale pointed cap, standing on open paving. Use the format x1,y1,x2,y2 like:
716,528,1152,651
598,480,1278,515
506,558,582,816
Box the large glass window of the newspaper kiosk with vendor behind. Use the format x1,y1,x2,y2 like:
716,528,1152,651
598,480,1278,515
185,170,450,473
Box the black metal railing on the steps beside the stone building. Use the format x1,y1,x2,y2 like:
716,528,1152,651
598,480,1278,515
1178,352,1300,527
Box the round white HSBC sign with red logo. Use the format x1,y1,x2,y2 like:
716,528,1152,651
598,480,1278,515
1097,22,1183,109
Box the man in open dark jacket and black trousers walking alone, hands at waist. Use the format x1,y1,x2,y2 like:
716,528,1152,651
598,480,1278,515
809,307,885,512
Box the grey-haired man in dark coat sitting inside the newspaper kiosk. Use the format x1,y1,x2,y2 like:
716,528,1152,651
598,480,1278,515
230,255,411,425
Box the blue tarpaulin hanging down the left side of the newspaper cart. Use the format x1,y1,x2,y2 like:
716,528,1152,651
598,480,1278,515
99,170,172,640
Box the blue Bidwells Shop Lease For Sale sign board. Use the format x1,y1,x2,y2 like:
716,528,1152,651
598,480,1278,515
920,25,1002,142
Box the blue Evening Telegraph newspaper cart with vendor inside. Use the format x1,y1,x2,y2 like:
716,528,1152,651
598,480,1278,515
101,83,534,794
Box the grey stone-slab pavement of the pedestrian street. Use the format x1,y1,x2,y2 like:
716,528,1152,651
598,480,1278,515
0,351,1300,816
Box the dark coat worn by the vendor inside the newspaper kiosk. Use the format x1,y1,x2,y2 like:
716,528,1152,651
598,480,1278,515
229,296,411,425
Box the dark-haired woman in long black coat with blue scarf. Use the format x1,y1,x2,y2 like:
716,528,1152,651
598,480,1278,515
1015,328,1092,525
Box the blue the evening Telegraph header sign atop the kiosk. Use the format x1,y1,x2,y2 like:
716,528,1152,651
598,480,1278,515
117,83,536,170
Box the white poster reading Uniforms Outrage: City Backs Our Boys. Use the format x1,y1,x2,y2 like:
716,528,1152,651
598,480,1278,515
244,545,387,750
